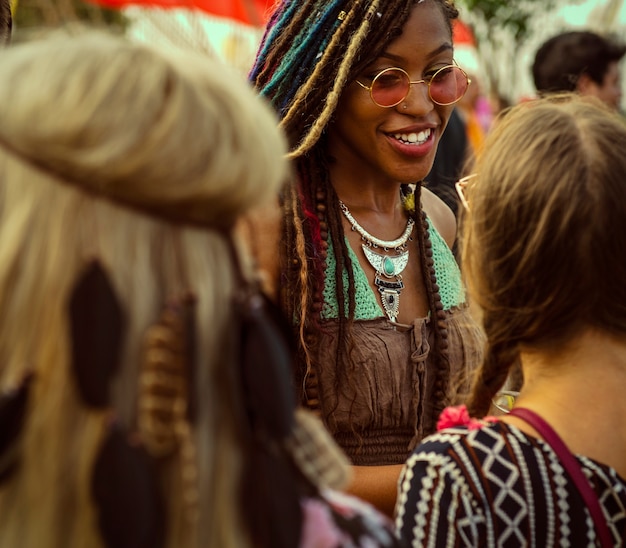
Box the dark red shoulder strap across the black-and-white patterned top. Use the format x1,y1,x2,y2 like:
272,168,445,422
509,407,613,548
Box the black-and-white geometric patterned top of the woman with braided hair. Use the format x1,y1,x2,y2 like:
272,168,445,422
396,422,626,548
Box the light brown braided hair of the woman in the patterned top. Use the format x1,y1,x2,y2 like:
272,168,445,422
462,95,626,416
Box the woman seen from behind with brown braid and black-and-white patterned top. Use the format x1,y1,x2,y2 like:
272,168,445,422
396,95,626,548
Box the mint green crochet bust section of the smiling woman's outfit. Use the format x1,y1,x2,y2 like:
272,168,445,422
322,220,465,320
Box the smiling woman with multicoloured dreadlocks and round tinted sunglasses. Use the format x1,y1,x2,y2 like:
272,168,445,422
250,0,482,513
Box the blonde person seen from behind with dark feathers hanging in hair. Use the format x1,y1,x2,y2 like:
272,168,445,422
0,31,396,548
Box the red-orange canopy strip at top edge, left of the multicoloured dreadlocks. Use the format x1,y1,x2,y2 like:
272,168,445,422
91,0,276,27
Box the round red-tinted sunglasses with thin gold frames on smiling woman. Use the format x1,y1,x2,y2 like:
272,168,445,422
356,65,471,108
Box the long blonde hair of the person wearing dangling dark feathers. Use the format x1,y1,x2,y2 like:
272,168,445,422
0,32,287,548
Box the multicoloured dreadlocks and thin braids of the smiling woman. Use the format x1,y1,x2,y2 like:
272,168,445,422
249,0,458,434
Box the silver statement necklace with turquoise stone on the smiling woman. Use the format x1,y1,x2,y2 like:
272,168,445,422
339,200,415,322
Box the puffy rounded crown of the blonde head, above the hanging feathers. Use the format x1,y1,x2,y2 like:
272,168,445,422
0,33,285,228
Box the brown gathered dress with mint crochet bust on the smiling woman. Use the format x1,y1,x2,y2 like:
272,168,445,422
302,220,484,465
